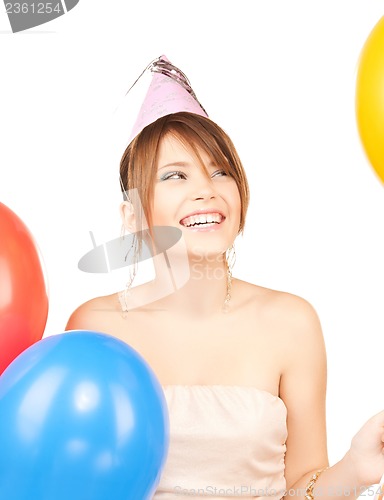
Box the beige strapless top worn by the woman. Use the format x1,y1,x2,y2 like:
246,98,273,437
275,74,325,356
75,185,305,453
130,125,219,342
153,385,288,500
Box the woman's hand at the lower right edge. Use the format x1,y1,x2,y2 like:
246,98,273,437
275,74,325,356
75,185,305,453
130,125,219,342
346,410,384,486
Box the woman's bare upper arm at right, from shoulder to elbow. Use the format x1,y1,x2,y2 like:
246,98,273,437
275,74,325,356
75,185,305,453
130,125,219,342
280,294,328,490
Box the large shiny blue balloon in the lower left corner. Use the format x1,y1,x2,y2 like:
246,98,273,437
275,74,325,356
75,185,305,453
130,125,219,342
0,330,169,500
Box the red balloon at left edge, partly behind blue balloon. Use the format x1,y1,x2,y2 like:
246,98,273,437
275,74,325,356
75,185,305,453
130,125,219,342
0,203,48,374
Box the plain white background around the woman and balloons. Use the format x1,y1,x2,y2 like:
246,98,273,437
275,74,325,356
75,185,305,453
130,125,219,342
0,0,384,464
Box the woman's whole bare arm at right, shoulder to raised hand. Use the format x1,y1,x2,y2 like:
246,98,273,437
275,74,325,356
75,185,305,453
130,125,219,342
280,296,384,500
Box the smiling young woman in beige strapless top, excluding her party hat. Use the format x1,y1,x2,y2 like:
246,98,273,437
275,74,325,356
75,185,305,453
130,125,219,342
67,58,384,500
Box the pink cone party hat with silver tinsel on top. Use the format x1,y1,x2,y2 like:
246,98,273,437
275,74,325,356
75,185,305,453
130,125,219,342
128,56,208,143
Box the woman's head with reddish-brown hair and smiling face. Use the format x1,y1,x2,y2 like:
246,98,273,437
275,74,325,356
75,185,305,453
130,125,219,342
120,112,249,258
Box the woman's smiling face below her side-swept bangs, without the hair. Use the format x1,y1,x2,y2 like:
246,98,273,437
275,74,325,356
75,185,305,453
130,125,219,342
151,133,241,257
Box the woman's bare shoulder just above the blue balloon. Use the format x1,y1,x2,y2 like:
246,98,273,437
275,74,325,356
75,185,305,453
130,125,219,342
65,293,119,333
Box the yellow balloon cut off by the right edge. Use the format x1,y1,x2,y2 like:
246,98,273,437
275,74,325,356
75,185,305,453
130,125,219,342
356,17,384,183
